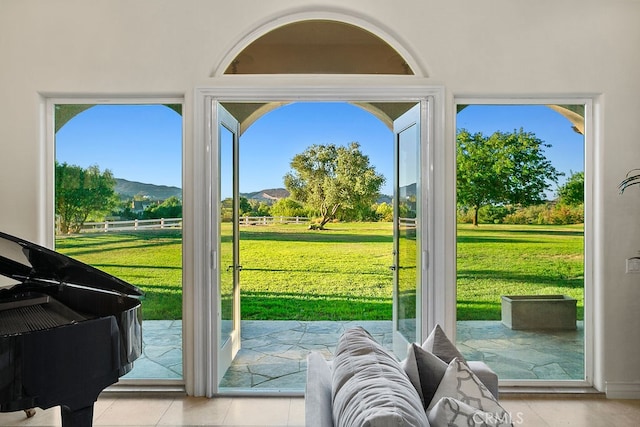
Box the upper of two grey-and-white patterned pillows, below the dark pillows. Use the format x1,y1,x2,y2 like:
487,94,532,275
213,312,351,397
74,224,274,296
427,358,508,419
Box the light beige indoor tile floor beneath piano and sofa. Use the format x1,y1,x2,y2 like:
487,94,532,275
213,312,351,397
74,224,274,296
0,395,640,427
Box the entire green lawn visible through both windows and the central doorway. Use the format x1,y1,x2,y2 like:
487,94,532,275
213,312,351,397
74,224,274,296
56,223,583,320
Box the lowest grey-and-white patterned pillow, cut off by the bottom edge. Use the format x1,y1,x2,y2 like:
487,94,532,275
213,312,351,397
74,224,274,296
427,397,512,427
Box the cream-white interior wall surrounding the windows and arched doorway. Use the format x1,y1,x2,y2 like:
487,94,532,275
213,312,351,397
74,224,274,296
0,0,640,397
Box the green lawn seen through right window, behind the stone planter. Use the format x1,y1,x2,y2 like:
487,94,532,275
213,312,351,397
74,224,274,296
457,224,584,320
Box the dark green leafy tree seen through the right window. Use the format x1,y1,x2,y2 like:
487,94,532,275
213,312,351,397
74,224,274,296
457,129,561,225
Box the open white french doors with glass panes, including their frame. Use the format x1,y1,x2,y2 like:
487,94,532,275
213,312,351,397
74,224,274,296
192,85,444,396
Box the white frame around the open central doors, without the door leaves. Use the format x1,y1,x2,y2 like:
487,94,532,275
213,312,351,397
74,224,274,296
191,83,444,397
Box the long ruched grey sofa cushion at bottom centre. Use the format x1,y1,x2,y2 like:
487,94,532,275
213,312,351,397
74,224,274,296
332,327,429,427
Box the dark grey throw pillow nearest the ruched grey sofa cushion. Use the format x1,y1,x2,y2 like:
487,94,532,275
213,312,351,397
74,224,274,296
402,344,447,409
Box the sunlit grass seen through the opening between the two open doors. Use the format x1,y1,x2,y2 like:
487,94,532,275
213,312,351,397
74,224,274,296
230,223,393,320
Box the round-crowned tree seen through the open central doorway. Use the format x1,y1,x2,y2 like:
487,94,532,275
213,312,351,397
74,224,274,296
284,142,385,229
